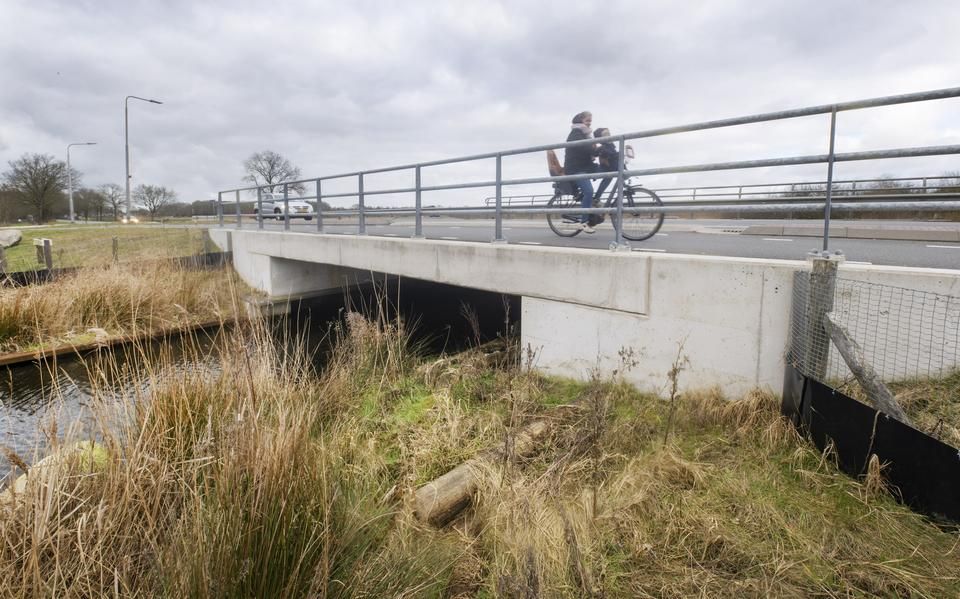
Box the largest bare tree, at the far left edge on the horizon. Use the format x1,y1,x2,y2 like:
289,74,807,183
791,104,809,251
3,154,80,222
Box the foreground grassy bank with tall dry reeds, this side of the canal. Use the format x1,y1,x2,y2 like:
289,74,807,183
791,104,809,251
0,314,960,597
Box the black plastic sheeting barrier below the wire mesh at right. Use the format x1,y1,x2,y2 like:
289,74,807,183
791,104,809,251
782,365,960,522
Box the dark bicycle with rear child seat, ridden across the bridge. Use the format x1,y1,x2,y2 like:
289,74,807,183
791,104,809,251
547,149,664,241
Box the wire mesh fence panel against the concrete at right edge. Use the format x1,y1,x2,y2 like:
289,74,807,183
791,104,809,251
787,272,960,382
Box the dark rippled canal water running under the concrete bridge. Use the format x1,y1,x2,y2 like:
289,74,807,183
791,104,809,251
0,279,520,487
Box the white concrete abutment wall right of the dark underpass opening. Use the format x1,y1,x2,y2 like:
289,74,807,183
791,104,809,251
521,255,804,394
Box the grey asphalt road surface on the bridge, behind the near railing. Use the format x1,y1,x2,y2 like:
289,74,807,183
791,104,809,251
242,218,960,269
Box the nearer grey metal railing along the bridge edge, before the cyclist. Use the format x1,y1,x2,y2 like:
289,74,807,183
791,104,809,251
217,87,960,253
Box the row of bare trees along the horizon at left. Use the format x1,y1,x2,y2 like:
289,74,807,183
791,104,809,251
0,150,304,223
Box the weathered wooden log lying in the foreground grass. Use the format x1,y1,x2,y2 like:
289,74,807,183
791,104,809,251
414,419,552,527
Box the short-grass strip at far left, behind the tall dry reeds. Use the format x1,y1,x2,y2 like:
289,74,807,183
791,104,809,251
4,225,203,272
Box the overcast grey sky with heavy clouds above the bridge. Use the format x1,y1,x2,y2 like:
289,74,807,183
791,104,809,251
0,0,960,206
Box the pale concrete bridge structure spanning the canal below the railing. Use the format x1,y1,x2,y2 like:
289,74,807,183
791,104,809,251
210,229,960,395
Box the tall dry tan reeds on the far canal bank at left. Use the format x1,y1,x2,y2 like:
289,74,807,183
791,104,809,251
0,263,243,352
